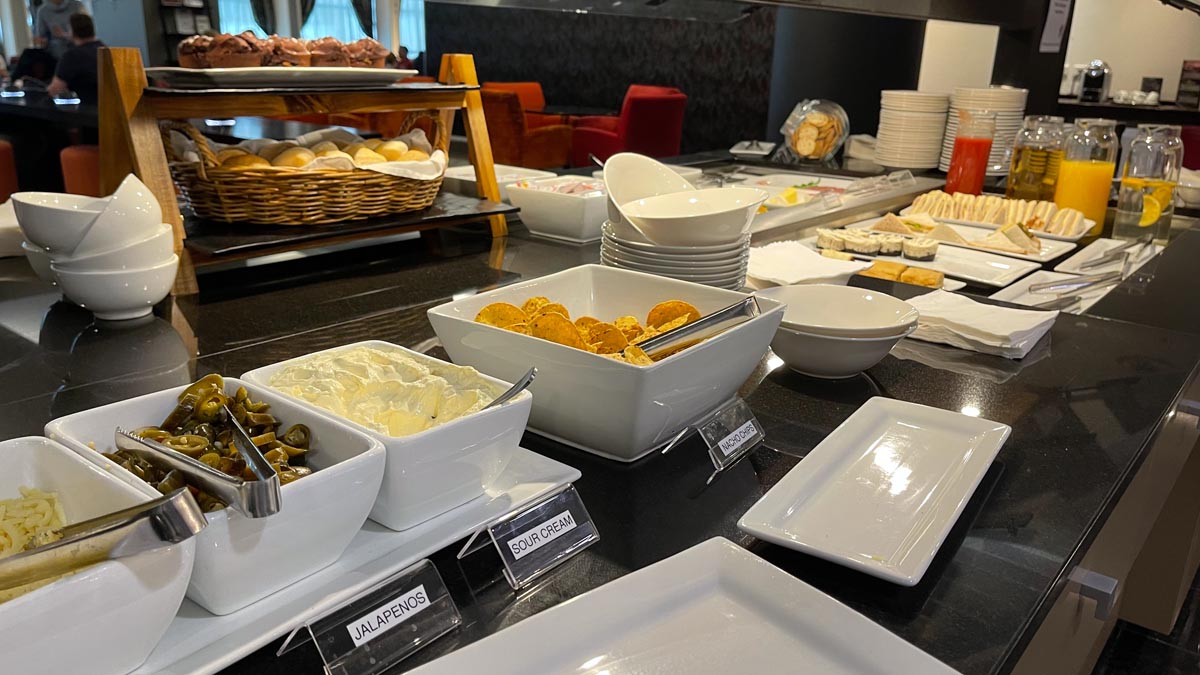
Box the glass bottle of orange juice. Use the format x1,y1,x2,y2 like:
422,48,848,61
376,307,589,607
1054,119,1120,234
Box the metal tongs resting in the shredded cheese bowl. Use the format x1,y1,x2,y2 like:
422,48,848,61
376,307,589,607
0,488,208,590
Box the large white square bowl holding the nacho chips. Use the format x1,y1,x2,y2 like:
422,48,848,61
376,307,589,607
428,264,785,461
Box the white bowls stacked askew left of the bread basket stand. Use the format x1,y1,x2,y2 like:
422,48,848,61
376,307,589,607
12,174,179,321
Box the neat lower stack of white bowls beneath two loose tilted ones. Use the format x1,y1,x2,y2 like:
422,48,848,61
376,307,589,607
600,222,750,285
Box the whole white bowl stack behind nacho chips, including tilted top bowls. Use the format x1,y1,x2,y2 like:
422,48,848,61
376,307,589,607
600,153,768,289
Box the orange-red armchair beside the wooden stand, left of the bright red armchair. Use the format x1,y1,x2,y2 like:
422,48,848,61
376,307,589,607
480,89,571,168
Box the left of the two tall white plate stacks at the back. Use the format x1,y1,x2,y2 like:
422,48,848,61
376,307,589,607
875,89,950,168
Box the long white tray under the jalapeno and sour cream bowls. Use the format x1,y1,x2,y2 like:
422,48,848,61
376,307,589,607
134,448,580,675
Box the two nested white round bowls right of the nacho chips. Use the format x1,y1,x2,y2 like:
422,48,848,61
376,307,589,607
755,285,919,380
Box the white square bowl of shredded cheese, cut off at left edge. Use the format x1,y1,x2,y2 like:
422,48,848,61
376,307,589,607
0,436,196,675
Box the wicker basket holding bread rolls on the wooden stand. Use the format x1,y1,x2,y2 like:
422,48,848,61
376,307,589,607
161,113,450,225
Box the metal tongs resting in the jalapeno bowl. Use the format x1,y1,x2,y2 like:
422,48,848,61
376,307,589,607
116,417,282,518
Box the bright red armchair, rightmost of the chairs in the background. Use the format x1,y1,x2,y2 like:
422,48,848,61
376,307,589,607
571,84,688,167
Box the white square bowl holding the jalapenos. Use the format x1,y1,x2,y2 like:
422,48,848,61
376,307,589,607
46,377,384,615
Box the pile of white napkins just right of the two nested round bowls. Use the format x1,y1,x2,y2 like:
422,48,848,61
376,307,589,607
908,291,1058,359
